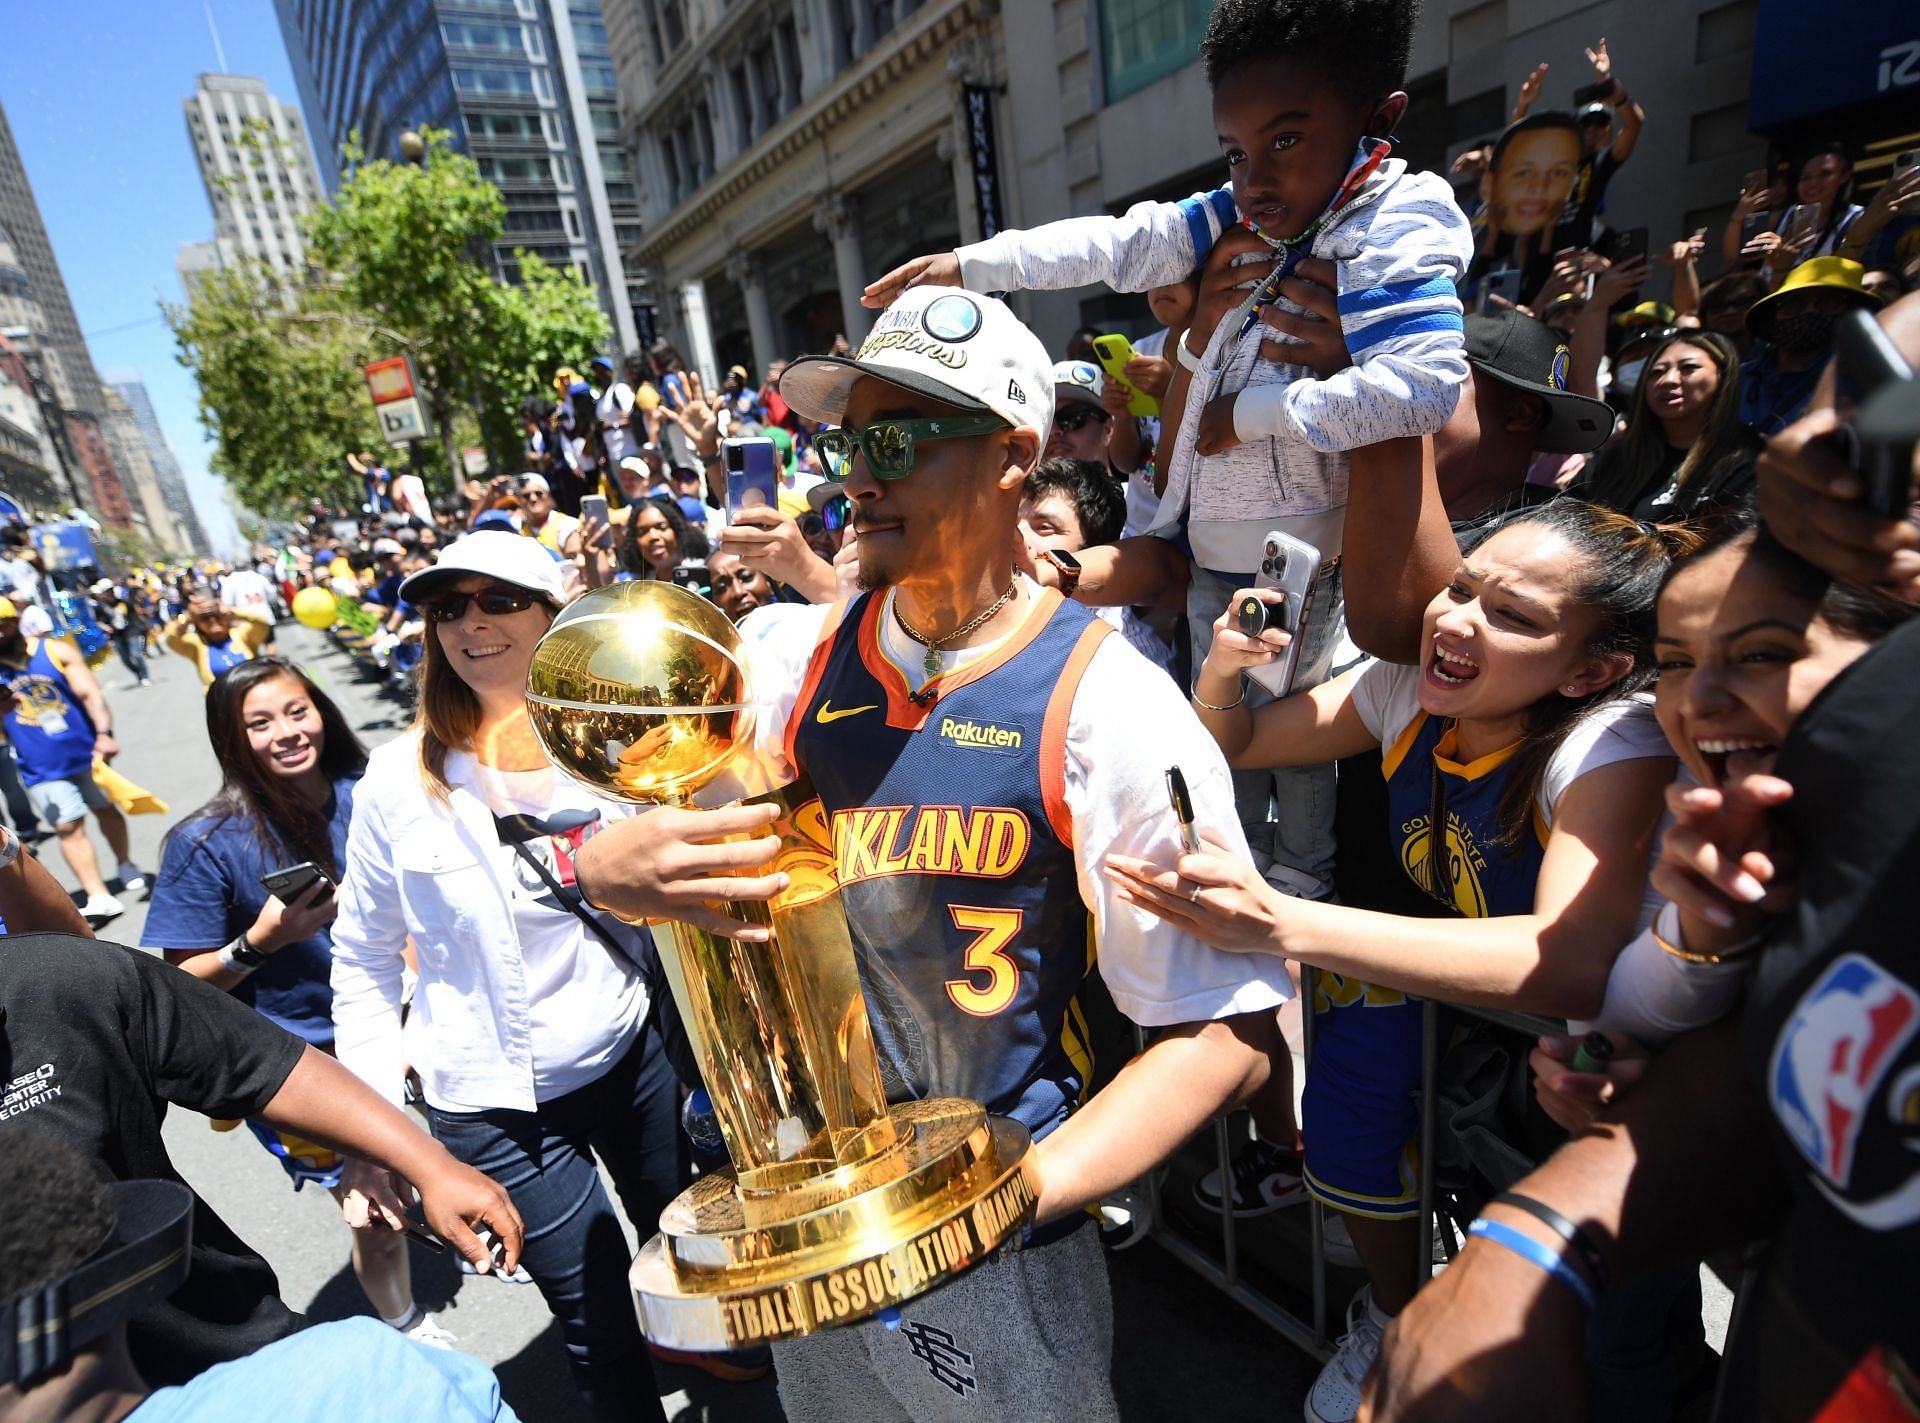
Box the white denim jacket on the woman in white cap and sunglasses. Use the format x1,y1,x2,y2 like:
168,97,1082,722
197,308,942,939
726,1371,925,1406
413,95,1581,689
332,732,647,1112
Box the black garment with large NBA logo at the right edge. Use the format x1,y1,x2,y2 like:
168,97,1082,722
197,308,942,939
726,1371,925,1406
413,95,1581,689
1722,622,1920,1421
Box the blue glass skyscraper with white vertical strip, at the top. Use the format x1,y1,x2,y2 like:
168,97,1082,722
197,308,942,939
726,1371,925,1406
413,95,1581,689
275,0,653,351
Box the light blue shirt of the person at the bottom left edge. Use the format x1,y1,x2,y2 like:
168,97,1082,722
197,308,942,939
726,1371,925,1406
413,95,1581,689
127,1313,518,1423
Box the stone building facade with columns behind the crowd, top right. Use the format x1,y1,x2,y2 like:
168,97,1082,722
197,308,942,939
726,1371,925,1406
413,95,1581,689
622,0,1920,362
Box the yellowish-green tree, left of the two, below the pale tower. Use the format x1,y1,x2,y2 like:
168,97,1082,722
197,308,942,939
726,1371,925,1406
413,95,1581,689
163,267,380,519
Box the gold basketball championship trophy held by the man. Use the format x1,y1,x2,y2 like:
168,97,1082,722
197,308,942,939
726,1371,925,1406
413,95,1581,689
526,582,1039,1350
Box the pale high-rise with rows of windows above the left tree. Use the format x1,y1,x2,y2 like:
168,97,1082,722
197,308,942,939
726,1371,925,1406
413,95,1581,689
182,75,321,280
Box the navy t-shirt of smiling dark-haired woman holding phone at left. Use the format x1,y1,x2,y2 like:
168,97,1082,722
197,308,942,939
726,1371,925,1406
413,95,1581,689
140,776,357,1049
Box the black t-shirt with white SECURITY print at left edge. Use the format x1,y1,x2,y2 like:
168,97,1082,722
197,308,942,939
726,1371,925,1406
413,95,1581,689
0,933,303,1385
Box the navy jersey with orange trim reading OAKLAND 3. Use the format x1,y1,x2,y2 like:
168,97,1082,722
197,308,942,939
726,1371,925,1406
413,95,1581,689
787,590,1112,1135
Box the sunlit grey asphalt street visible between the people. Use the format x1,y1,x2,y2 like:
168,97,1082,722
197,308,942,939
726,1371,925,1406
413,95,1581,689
56,622,1320,1423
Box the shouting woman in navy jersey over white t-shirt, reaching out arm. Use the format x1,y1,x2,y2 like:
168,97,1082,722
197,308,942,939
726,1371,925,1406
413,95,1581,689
1110,499,1697,1417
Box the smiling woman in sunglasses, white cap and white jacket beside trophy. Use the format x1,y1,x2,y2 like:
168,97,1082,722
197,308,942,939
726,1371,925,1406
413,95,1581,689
332,532,770,1419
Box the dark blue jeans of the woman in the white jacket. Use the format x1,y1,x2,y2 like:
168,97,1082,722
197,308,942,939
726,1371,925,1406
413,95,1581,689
428,1024,682,1423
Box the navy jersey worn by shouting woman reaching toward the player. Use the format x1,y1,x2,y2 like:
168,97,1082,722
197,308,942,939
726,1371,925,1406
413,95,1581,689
1380,712,1548,920
